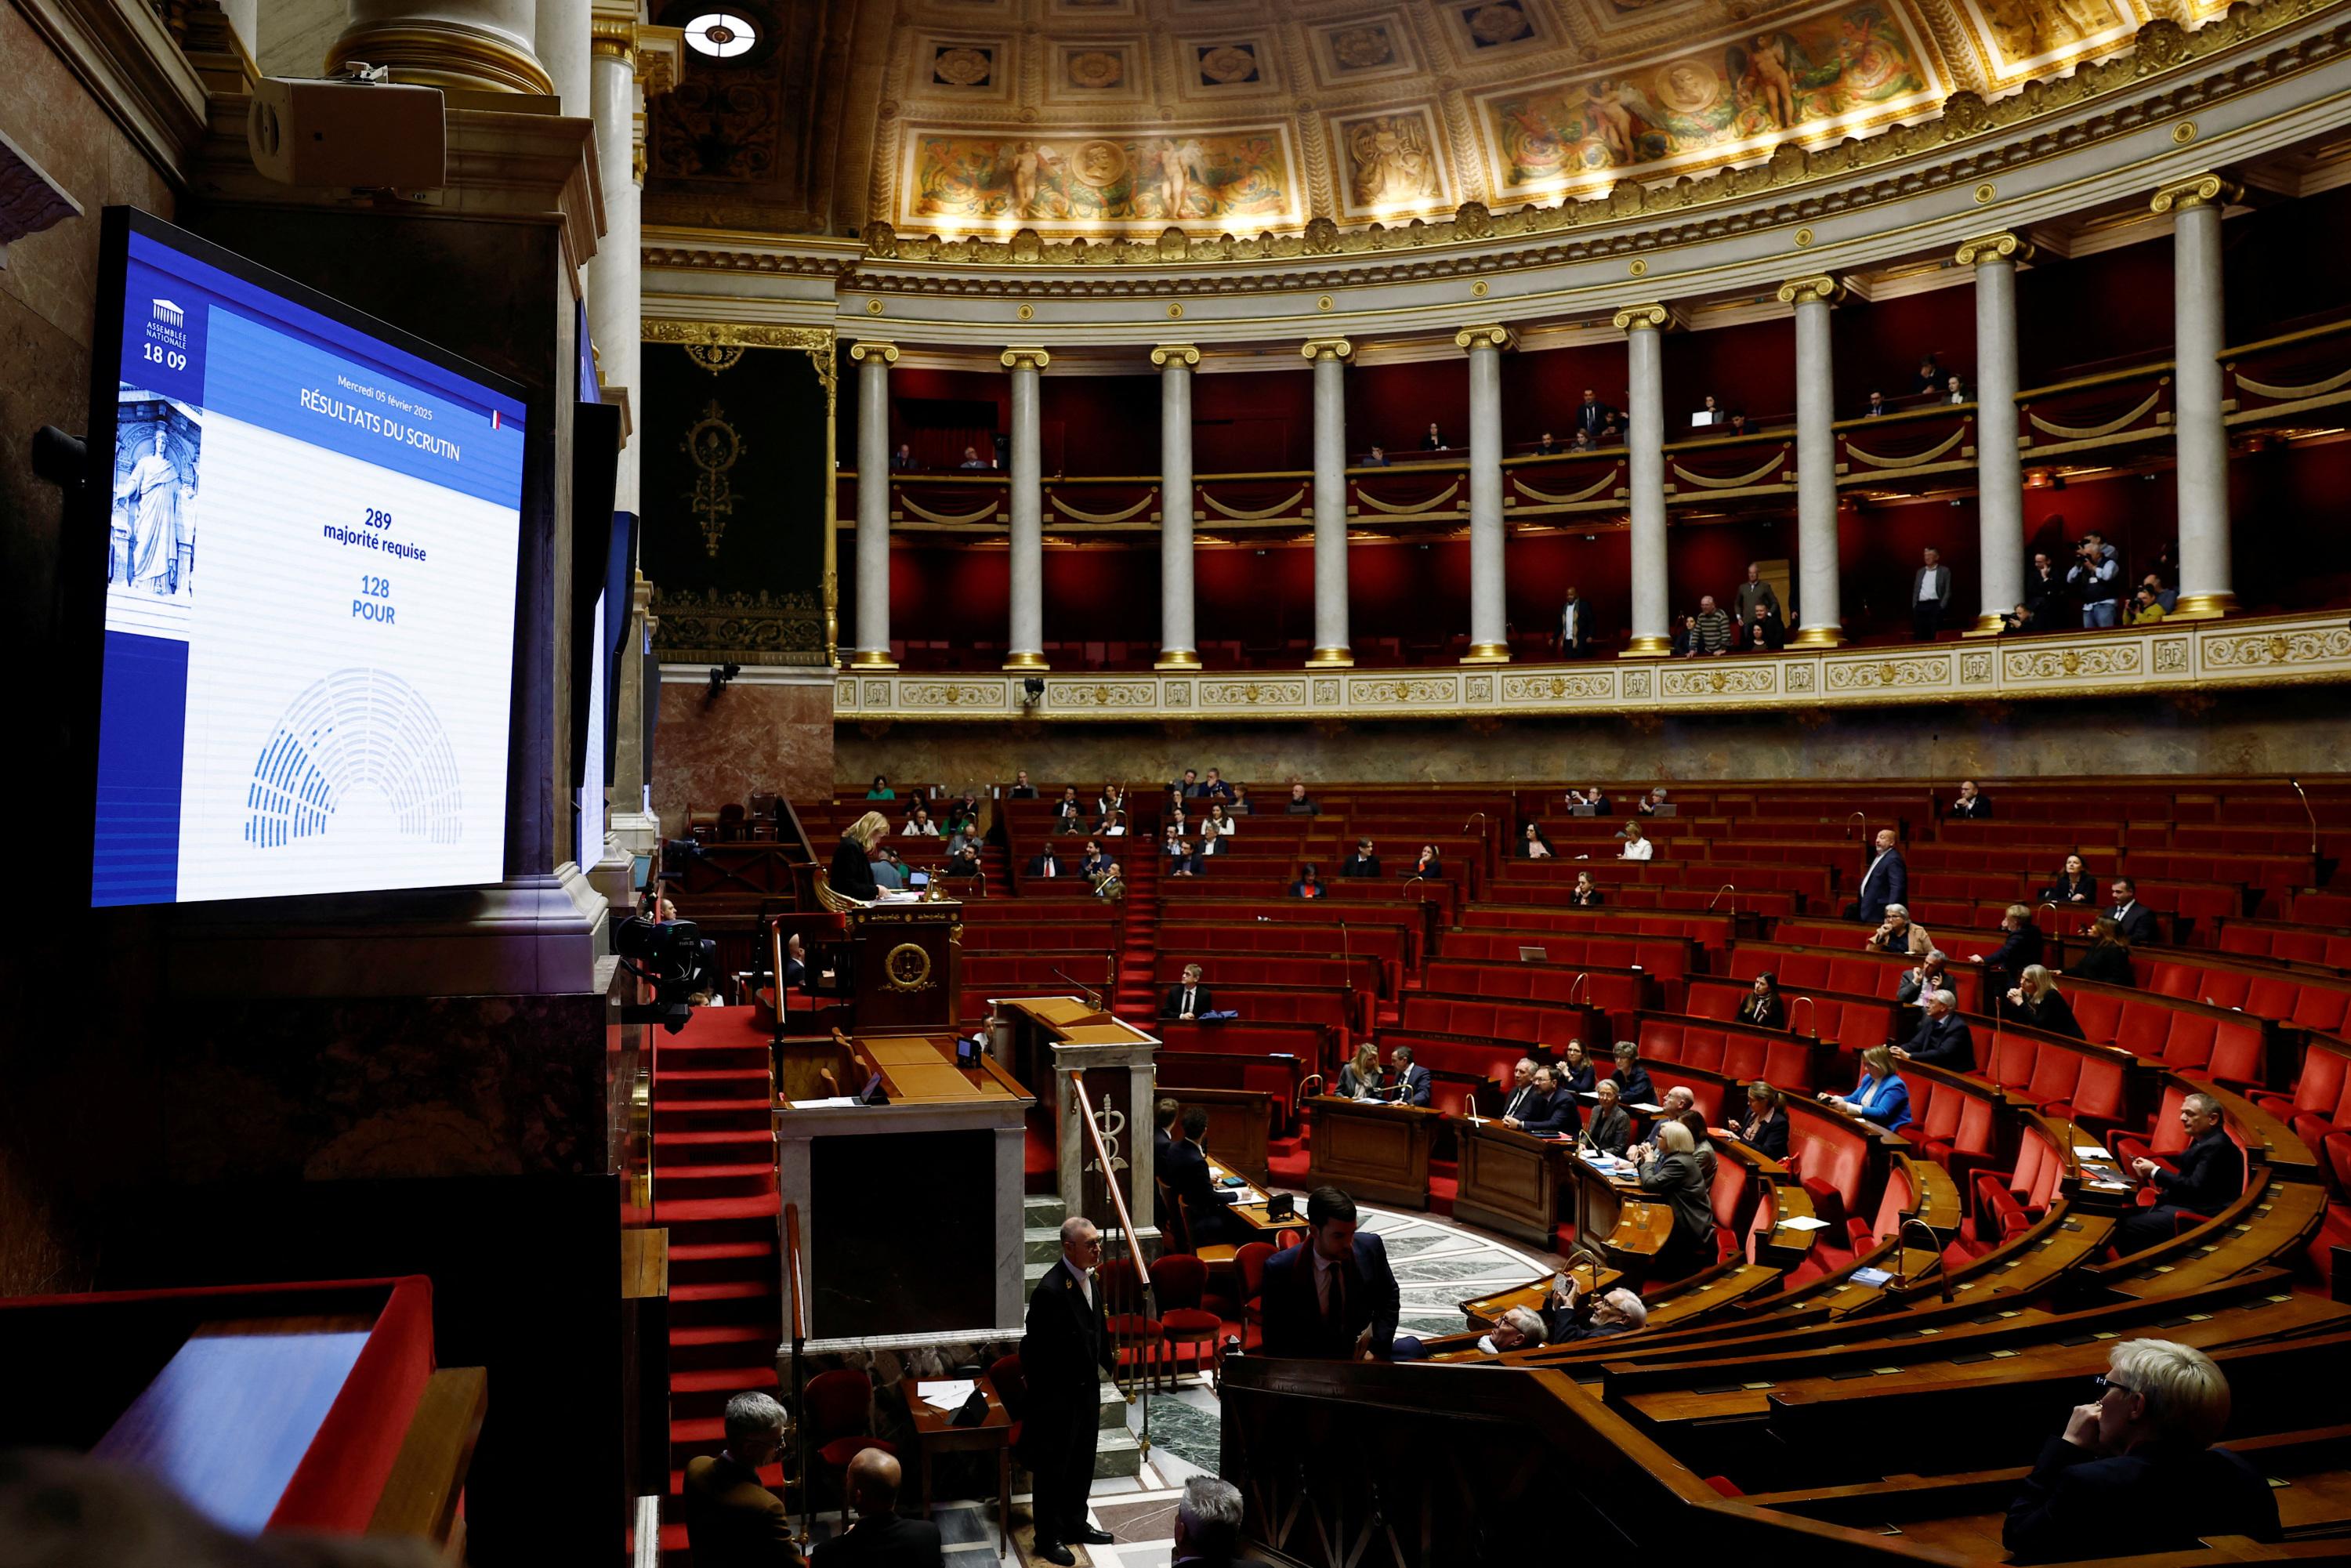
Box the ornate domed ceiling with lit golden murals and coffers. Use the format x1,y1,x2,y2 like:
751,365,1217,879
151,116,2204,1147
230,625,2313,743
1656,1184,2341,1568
649,0,2217,237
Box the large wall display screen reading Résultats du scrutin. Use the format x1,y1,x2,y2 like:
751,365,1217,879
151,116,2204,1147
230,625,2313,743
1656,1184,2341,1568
92,212,524,905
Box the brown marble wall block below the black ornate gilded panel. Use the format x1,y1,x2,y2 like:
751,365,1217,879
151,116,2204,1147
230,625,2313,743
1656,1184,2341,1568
654,677,835,835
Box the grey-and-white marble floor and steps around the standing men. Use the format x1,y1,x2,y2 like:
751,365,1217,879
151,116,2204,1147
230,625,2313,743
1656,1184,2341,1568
856,1204,1554,1568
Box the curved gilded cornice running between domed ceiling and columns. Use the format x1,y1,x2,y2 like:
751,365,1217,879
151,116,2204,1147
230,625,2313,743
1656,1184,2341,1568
818,0,2351,296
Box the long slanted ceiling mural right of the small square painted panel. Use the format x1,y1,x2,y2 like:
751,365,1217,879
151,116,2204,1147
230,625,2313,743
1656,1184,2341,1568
1483,2,1928,188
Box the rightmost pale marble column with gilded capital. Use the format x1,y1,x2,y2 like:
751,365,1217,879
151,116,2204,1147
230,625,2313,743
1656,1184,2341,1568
2154,174,2243,621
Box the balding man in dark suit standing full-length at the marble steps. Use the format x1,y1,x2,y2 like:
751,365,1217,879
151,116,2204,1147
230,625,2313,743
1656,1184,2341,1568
1020,1215,1117,1568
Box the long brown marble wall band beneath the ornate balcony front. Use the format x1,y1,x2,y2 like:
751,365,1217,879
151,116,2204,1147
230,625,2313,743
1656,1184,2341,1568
832,691,2351,790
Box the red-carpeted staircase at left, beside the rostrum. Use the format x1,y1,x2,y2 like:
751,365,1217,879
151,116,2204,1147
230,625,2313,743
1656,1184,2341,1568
654,1006,783,1554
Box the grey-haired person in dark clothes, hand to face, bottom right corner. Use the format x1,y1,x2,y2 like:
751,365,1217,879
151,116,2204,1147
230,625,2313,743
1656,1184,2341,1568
2001,1340,2283,1563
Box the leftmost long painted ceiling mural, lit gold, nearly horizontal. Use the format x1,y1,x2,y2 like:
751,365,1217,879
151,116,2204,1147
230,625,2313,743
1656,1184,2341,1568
907,129,1298,226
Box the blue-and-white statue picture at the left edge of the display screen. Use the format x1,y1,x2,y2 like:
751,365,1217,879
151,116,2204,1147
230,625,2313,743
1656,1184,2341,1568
106,383,205,637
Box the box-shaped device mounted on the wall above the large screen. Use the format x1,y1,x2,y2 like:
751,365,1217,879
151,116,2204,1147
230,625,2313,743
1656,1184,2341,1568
245,61,449,190
